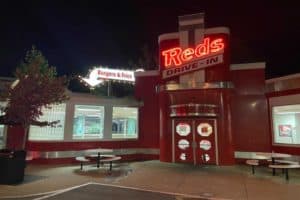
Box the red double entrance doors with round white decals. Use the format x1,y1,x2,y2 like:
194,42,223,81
172,118,218,165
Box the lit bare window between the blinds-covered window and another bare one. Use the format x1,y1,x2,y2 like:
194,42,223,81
73,105,104,139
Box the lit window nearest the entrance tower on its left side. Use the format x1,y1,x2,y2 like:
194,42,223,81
112,107,138,139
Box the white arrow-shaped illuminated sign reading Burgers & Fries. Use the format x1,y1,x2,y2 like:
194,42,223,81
79,67,135,87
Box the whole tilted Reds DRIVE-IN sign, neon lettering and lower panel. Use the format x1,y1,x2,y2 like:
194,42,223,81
161,37,225,78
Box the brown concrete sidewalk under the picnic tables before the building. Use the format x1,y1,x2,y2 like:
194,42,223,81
0,161,300,200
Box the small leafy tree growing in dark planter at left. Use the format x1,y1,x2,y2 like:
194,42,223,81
0,46,68,149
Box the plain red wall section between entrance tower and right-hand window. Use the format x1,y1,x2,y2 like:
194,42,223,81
231,69,271,152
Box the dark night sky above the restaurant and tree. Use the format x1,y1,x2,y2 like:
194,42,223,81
0,0,300,78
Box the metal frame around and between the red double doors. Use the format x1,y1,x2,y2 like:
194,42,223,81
171,117,219,165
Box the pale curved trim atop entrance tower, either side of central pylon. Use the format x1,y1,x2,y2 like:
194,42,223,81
158,27,230,43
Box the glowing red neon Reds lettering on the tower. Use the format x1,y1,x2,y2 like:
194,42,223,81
162,38,225,68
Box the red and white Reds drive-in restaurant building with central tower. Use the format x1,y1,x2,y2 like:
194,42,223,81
1,14,300,165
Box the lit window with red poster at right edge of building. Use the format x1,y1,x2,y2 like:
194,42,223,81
272,104,300,145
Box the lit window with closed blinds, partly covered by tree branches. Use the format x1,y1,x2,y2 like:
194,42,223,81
29,103,66,141
